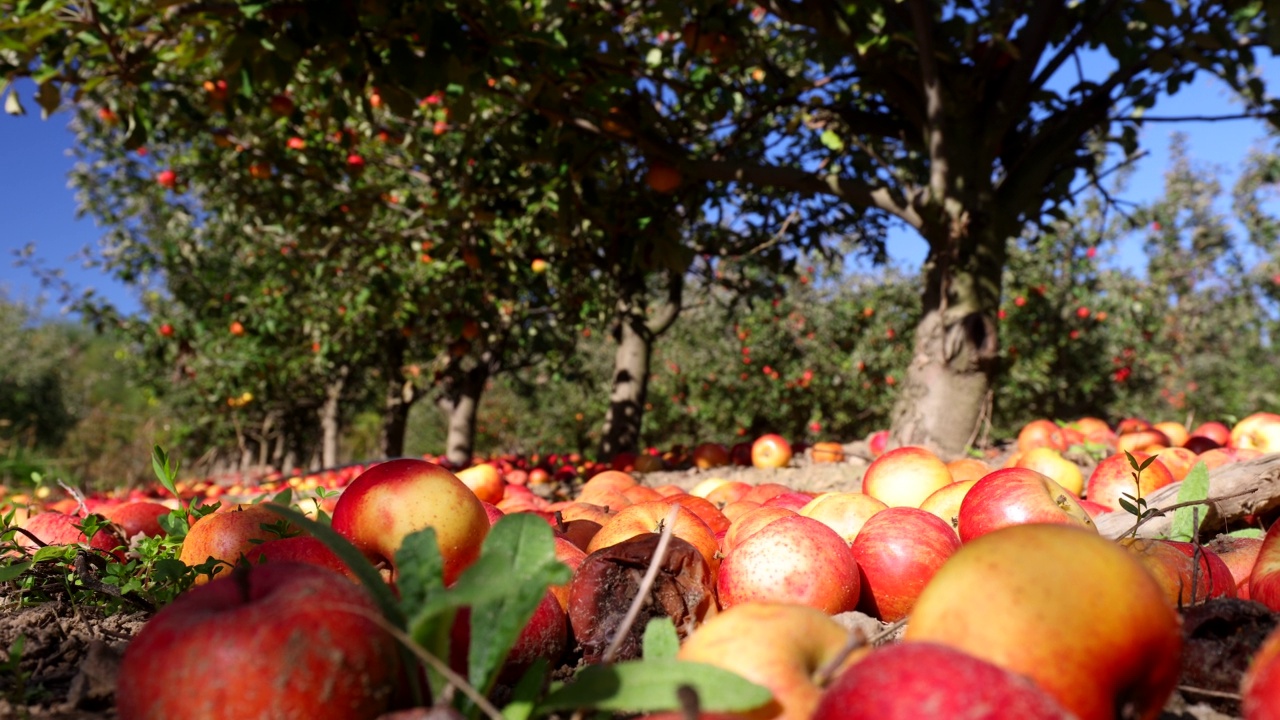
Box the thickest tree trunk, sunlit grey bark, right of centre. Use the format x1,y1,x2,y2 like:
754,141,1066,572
890,211,1007,460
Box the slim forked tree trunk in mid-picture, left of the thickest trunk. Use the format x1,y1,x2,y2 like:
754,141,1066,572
600,270,684,459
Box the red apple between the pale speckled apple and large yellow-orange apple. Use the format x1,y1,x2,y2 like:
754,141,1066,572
850,507,960,623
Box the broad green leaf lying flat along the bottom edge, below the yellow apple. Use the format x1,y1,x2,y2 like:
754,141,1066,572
538,660,773,712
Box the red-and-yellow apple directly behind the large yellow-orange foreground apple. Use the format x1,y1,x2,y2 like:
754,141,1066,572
956,468,1097,542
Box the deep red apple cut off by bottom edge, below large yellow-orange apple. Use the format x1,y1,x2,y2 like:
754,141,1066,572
813,642,1074,720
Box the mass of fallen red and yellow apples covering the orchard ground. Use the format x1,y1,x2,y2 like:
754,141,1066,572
7,413,1280,720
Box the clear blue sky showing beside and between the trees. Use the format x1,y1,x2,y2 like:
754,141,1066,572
0,60,1280,320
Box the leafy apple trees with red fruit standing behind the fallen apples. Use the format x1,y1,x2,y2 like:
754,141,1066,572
0,0,1277,481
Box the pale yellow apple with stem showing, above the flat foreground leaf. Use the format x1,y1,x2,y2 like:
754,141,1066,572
676,602,867,720
